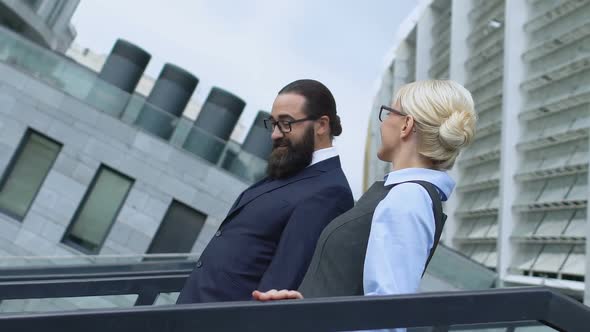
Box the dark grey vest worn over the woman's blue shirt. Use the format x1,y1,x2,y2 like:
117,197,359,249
299,181,446,297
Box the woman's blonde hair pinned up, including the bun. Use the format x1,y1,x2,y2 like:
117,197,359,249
394,80,477,170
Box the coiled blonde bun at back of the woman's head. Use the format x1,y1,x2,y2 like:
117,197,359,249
439,111,475,150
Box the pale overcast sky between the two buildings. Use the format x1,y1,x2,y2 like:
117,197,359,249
72,0,417,198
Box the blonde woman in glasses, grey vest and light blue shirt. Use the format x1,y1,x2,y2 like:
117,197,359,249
252,80,476,314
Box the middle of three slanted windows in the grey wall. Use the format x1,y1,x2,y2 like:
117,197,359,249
62,165,133,254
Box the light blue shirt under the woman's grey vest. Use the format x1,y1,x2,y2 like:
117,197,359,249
363,168,455,330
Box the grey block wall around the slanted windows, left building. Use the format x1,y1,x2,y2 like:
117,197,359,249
0,63,247,265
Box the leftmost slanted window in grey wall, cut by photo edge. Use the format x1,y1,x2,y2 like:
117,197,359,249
0,130,61,220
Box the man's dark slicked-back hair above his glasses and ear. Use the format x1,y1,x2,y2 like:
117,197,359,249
279,79,342,137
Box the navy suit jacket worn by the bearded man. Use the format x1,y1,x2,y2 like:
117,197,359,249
177,157,354,303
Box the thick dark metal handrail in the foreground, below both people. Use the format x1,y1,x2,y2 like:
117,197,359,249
0,287,590,332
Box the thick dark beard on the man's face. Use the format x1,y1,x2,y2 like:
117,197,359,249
266,126,315,180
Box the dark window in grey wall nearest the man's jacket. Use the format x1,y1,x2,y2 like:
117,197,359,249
147,201,207,254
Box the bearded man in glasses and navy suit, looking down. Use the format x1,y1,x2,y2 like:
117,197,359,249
177,80,354,304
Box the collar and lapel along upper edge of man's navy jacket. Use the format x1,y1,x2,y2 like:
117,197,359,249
226,157,340,219
